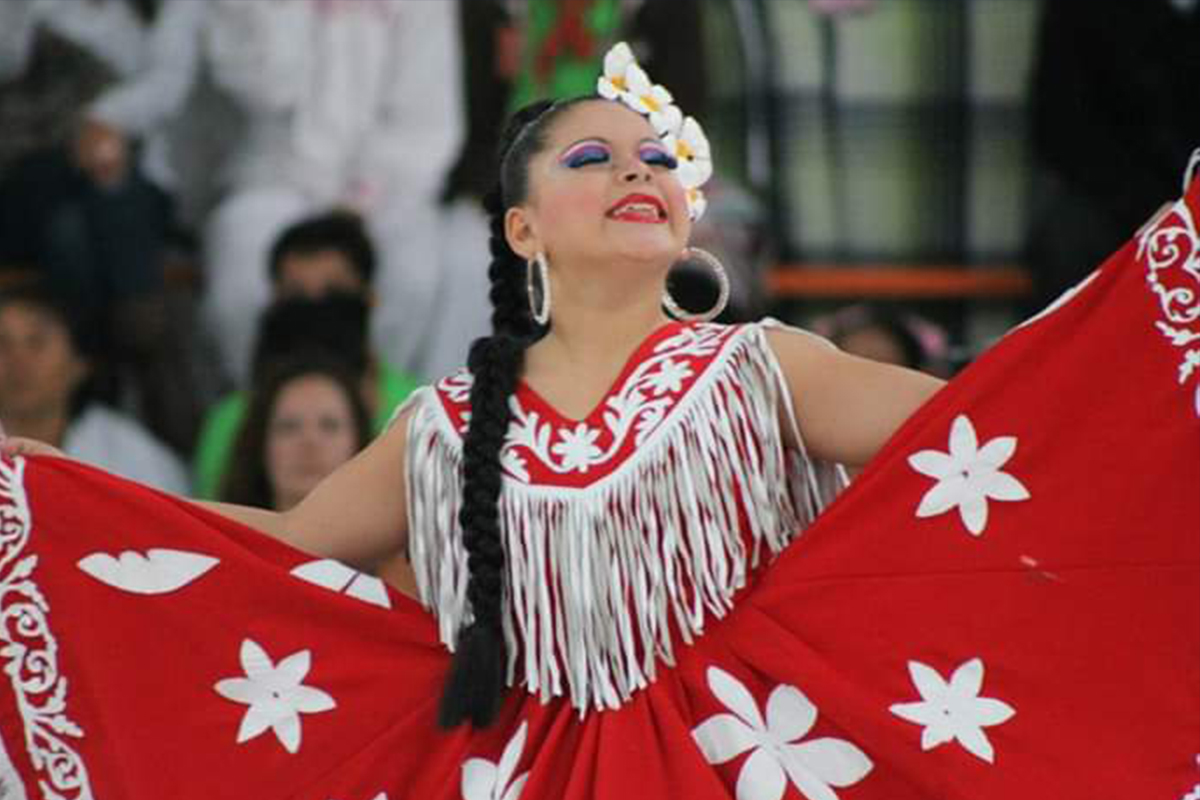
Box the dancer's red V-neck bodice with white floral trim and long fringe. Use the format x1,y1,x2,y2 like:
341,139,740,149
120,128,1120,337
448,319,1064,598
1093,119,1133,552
406,323,839,709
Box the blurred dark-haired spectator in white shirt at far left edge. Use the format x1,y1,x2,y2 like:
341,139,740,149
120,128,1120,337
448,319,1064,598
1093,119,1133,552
0,281,187,494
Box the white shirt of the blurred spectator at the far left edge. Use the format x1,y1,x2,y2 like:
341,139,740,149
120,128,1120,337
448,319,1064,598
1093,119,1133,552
62,403,187,494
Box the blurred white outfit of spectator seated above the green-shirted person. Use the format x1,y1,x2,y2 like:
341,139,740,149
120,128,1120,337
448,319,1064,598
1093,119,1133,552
204,0,463,379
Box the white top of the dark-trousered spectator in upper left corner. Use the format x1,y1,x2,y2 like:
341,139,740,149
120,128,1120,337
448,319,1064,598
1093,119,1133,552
0,0,208,186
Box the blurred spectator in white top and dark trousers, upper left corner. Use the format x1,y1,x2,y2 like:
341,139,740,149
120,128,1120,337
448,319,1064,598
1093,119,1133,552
0,0,208,449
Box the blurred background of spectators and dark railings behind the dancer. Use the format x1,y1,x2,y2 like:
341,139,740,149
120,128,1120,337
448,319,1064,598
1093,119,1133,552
0,0,1200,507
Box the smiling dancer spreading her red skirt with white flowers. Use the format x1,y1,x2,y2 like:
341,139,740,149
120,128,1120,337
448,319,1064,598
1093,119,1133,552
0,45,1200,800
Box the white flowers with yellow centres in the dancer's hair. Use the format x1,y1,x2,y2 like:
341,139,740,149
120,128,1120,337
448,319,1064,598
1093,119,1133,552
596,42,713,222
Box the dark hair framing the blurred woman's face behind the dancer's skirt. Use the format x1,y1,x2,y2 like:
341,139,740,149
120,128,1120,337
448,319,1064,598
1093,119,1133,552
220,351,371,509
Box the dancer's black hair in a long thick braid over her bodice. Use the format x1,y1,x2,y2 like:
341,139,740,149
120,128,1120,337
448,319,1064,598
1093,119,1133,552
438,97,594,728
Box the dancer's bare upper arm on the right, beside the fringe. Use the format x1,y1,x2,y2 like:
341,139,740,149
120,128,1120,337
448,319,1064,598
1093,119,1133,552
766,329,944,468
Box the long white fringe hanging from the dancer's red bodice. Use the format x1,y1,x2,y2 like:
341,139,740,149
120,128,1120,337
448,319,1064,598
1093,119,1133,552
406,326,844,714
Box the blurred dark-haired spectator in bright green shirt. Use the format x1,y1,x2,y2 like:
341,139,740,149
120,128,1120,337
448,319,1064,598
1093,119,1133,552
192,212,418,500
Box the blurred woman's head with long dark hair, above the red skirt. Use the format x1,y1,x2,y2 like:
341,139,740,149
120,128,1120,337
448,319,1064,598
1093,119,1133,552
220,353,371,511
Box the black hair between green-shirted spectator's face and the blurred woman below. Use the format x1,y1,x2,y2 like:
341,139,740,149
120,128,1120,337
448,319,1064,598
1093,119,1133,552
251,291,371,381
